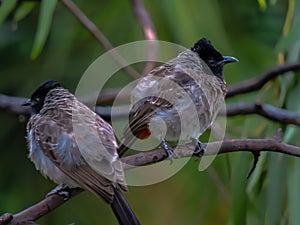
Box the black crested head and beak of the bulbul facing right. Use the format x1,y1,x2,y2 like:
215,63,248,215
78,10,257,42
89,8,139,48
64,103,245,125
191,38,238,78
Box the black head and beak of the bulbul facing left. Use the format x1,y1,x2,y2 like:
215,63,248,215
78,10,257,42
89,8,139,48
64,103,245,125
22,80,61,113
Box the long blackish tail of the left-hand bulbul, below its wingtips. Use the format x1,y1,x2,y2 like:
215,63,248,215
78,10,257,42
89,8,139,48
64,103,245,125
111,185,141,225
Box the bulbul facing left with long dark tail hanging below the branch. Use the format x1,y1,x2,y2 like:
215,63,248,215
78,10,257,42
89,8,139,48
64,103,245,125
23,81,140,225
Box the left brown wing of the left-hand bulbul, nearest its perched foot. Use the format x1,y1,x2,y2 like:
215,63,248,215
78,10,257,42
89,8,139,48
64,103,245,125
33,112,114,203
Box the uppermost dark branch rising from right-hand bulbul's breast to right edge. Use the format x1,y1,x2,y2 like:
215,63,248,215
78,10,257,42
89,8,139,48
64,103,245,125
226,61,300,98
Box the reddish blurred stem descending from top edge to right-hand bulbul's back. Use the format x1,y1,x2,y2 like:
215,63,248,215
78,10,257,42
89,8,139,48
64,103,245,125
131,0,158,75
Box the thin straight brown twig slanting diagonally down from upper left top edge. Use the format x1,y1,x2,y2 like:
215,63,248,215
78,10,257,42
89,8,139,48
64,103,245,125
61,0,140,79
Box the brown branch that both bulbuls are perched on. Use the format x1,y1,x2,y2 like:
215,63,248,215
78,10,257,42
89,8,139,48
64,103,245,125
0,129,300,225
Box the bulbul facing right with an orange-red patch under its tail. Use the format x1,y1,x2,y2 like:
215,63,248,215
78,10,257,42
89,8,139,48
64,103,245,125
118,38,238,157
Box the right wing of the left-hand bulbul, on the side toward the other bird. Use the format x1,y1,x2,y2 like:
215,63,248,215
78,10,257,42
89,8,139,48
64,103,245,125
72,102,127,191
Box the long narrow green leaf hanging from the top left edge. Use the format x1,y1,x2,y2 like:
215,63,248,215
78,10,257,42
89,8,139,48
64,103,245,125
31,0,57,59
